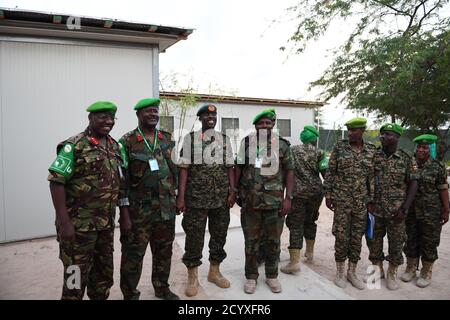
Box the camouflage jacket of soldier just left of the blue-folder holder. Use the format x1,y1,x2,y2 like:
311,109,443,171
323,140,376,205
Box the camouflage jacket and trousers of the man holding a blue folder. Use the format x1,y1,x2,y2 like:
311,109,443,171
367,147,417,266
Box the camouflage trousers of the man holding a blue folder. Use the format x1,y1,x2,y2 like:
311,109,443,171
366,217,406,266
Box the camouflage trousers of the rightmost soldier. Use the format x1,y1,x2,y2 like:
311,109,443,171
403,212,442,262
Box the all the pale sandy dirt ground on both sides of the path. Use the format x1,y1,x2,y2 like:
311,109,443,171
0,205,450,300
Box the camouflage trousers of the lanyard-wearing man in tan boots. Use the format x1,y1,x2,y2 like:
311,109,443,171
241,208,284,279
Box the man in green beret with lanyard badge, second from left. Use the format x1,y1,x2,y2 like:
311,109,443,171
119,98,179,300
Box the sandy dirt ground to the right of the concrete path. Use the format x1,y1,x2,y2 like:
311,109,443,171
282,201,450,300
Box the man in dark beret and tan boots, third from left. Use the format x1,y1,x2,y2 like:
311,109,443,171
177,104,236,297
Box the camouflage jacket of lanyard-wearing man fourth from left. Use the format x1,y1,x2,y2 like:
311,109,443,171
237,133,294,210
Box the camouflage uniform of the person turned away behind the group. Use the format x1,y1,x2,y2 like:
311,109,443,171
286,143,325,249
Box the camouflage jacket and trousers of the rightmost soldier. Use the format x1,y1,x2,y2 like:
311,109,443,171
404,158,448,262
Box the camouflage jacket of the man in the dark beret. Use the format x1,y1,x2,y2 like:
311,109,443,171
179,130,234,209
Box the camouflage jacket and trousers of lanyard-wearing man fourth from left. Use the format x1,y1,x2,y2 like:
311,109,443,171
237,133,294,279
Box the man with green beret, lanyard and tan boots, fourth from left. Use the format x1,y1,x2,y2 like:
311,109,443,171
236,110,294,293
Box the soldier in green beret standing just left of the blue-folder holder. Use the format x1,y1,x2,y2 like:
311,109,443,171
323,118,376,290
